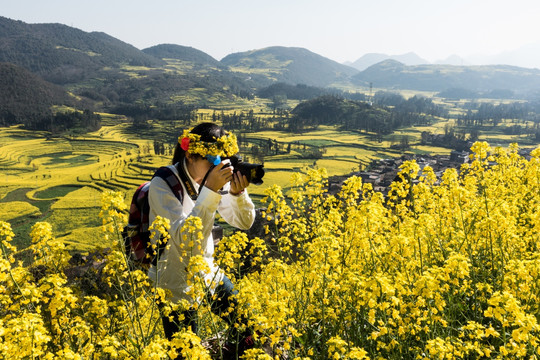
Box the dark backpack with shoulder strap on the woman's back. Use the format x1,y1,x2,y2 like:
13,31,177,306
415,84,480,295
122,166,183,266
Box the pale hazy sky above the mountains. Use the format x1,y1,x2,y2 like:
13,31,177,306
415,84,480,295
0,0,540,62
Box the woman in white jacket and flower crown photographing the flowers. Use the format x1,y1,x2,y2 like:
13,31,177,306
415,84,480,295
148,123,255,355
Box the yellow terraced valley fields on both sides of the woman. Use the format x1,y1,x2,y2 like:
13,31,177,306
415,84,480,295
0,119,456,250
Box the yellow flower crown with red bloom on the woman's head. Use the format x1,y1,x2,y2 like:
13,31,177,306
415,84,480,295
178,129,238,157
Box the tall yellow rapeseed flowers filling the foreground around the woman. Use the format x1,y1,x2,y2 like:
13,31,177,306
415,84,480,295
0,142,540,360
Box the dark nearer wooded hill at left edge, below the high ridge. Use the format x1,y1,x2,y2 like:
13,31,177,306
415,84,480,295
0,63,75,126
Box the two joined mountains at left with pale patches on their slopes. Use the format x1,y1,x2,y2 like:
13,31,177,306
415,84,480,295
0,17,252,111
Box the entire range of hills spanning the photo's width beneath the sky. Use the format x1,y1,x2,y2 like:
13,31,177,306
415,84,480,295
0,17,540,115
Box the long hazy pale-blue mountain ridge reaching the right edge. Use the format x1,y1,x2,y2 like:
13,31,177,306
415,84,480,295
352,60,540,92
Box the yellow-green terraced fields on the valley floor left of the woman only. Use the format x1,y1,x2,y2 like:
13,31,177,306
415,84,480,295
0,124,160,249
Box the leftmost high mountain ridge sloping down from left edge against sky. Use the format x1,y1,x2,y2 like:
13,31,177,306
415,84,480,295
0,16,164,84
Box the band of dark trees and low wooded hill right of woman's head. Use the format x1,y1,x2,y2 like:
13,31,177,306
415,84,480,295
201,94,448,136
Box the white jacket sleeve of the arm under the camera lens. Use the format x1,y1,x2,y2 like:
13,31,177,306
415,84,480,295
218,189,255,230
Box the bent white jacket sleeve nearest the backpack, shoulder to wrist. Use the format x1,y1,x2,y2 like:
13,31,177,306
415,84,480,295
148,177,221,255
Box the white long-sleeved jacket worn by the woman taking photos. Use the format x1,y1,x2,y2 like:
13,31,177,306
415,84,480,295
148,164,255,302
